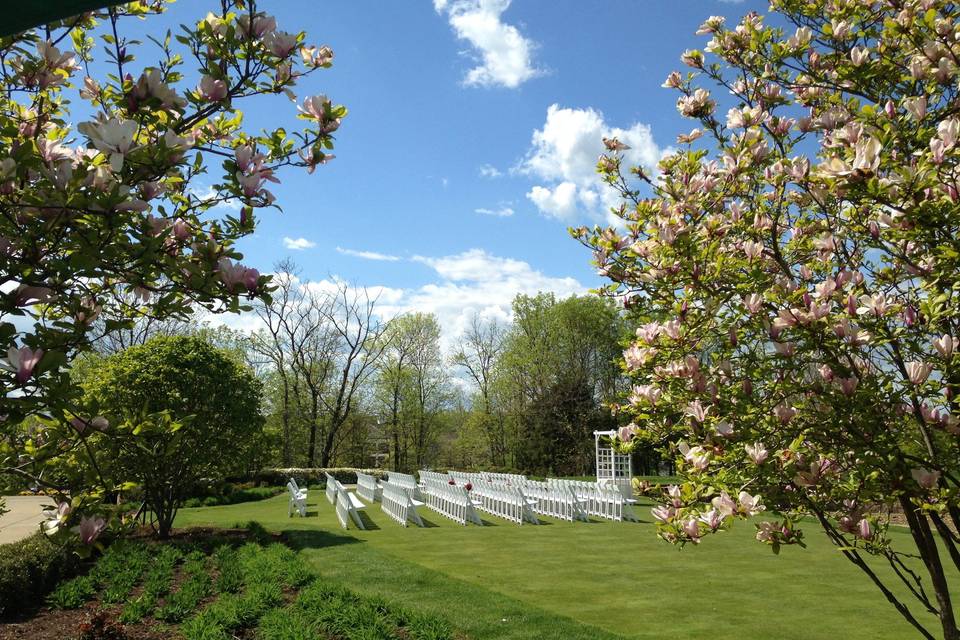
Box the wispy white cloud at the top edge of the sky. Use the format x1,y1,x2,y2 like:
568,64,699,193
433,0,540,89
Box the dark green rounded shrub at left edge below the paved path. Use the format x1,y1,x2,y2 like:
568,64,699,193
0,533,79,619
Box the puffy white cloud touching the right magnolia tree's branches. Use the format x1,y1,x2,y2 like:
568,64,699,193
517,104,666,222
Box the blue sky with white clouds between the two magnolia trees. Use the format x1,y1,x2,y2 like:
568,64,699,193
135,0,766,339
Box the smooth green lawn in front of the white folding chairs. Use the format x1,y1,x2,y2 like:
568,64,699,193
177,488,956,640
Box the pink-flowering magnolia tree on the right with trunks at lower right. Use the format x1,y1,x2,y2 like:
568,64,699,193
574,0,960,639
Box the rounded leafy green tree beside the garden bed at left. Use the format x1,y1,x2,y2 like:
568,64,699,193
81,336,263,537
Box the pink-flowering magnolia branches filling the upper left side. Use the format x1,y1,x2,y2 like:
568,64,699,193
0,0,346,542
